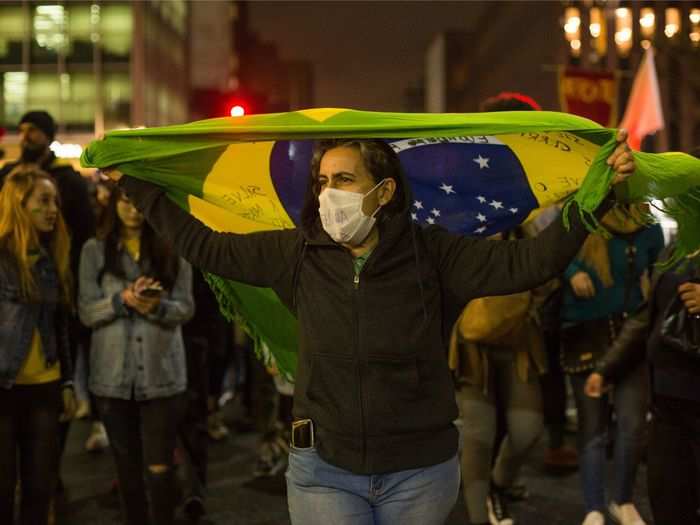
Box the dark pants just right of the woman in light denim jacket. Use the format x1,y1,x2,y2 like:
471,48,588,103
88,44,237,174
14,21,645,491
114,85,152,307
178,337,209,498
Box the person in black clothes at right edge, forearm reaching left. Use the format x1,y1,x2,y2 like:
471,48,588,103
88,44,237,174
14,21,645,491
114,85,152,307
585,145,700,525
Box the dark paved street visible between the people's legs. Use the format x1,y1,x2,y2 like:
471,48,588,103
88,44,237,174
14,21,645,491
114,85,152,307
58,414,651,525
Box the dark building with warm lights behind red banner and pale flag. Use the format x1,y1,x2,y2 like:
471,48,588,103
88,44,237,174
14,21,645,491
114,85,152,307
424,0,700,151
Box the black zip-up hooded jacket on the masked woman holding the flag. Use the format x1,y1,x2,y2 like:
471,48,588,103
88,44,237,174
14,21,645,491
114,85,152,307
120,177,609,474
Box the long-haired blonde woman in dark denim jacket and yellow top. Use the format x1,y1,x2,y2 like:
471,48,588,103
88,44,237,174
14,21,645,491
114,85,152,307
0,169,75,524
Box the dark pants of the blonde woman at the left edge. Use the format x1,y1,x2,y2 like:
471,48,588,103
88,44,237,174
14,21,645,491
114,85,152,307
0,381,61,525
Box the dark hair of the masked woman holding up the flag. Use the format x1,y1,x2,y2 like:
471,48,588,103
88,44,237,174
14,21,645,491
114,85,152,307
301,139,406,229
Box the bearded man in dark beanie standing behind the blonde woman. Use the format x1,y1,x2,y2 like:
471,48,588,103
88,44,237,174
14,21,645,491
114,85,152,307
0,110,95,500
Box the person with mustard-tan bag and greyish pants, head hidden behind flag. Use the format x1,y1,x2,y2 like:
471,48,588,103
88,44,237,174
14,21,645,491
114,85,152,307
450,229,547,525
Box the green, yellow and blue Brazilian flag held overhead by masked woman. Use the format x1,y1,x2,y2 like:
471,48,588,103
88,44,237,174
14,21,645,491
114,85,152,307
81,108,700,377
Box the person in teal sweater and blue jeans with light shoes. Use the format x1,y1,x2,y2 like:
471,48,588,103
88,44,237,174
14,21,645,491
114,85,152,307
561,206,664,525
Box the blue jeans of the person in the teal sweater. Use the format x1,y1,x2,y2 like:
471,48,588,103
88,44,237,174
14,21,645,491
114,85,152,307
570,366,647,512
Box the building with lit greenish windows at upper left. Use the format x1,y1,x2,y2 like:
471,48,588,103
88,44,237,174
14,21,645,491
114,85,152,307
0,0,191,162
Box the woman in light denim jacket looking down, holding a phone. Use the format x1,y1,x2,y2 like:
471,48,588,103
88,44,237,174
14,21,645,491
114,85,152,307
79,184,194,525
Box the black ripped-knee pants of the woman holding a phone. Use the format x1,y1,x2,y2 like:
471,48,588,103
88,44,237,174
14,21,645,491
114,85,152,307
97,395,182,525
